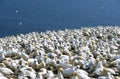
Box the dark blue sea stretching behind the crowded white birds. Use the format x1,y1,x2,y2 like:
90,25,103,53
0,0,120,37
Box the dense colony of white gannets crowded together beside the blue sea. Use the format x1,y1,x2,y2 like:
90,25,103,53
0,26,120,79
